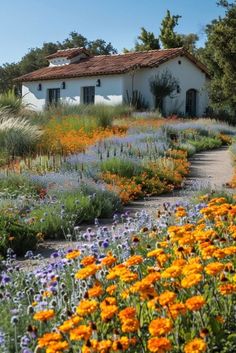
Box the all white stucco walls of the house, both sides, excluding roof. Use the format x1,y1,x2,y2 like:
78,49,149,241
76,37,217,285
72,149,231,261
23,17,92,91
22,57,208,116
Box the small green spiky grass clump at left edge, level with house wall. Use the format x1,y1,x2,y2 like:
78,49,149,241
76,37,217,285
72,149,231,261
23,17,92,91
0,90,25,114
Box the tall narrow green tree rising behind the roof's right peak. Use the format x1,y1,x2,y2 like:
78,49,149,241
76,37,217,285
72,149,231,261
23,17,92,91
160,10,183,49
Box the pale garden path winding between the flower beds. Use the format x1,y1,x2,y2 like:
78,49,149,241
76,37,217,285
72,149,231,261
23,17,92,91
19,148,233,270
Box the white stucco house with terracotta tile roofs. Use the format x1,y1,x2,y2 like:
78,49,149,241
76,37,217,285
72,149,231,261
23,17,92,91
16,48,209,116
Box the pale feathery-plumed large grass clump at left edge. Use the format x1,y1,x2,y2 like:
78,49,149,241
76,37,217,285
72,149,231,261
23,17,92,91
0,110,42,157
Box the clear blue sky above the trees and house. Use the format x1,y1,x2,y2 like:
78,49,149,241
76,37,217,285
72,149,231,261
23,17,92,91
0,0,224,65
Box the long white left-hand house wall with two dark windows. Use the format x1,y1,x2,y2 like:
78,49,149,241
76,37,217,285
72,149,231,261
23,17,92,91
22,75,123,111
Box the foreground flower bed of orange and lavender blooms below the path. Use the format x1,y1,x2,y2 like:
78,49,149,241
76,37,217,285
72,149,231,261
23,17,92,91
0,197,236,353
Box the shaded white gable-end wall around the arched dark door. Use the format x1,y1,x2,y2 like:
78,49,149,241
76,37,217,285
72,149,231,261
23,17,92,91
123,57,208,116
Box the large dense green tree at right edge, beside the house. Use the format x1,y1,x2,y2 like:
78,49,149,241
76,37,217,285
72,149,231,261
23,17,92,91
200,1,236,116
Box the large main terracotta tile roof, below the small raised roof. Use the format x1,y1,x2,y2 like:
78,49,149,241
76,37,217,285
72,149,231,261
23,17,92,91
15,48,208,82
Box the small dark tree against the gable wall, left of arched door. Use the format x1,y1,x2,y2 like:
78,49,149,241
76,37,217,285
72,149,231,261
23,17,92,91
149,70,178,112
